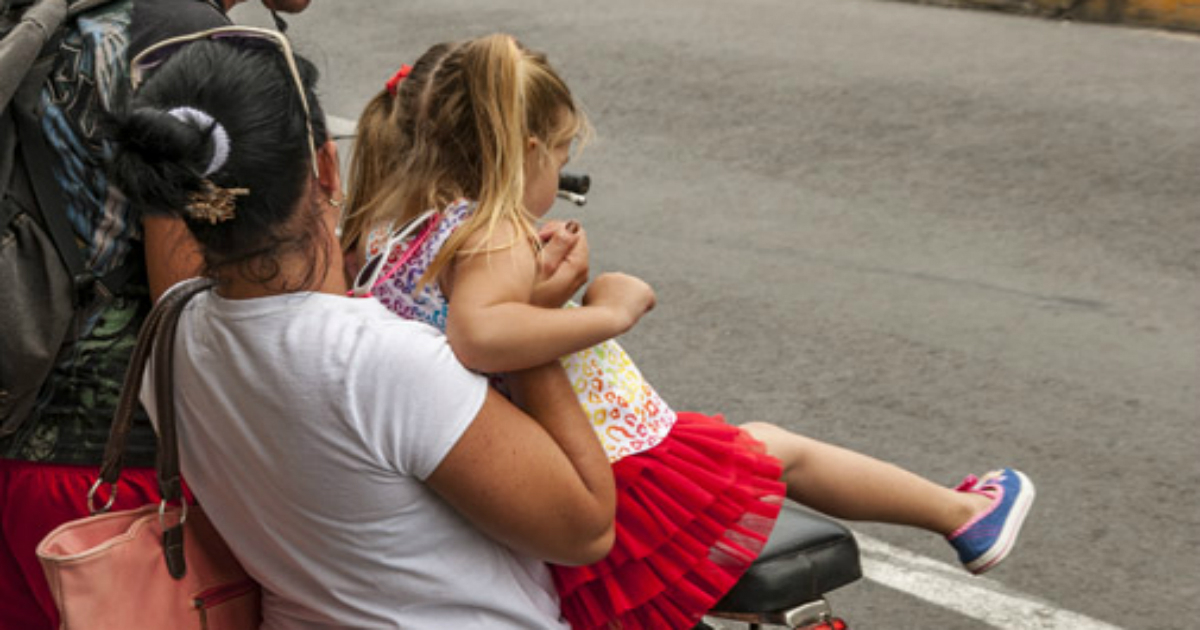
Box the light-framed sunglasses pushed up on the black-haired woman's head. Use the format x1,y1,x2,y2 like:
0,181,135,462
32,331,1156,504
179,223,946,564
130,26,318,175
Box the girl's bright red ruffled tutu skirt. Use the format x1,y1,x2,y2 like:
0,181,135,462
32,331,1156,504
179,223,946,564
552,412,785,630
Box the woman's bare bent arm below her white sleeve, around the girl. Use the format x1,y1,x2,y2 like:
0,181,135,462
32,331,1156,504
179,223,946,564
426,362,617,565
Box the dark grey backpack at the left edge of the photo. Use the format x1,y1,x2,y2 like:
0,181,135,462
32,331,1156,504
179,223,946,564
0,0,136,438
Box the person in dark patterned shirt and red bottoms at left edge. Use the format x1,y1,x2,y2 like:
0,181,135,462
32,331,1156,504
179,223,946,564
0,6,321,630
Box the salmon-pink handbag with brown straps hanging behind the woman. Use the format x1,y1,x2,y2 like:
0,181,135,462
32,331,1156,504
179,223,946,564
37,280,262,630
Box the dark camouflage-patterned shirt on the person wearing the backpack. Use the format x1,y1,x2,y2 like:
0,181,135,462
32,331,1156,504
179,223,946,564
0,0,154,466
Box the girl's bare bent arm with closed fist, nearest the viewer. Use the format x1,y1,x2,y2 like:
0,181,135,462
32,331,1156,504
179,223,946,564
443,222,654,373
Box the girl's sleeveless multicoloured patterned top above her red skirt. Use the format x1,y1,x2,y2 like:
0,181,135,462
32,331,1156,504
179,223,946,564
359,202,676,462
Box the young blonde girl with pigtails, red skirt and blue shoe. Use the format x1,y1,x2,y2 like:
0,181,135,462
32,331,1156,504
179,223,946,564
343,35,1034,629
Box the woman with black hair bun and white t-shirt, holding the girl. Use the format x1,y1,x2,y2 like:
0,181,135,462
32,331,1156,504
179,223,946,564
114,28,616,629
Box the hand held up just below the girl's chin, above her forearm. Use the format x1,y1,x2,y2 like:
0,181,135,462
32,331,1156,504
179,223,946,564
529,221,589,308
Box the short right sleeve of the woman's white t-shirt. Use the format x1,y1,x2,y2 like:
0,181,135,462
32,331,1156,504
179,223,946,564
352,313,487,480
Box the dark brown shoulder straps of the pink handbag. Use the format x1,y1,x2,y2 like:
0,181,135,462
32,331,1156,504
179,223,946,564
88,278,214,580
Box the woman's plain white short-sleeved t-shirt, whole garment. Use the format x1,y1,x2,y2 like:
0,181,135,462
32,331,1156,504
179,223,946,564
143,292,566,630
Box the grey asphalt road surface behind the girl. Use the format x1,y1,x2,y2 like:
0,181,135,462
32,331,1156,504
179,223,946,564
235,0,1200,630
